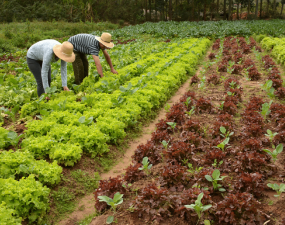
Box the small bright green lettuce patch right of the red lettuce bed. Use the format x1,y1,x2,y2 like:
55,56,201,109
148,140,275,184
256,35,285,65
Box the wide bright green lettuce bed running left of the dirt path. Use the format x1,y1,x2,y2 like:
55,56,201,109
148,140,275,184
0,39,211,224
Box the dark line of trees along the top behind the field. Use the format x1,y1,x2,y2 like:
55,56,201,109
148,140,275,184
0,0,285,24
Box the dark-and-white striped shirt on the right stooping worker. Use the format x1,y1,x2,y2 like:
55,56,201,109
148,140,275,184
68,34,100,56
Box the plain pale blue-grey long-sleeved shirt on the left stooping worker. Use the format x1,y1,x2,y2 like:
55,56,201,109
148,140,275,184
27,39,67,90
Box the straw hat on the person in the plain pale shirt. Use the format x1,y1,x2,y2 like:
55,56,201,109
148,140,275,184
53,41,75,62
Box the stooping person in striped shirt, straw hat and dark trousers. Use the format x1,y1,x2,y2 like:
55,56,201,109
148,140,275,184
68,33,118,84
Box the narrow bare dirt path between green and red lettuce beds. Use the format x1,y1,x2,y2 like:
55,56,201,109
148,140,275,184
58,73,196,225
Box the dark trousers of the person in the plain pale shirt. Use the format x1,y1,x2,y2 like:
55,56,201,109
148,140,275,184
27,57,51,97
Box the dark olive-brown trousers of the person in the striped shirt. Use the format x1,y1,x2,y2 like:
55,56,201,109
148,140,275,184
72,52,89,85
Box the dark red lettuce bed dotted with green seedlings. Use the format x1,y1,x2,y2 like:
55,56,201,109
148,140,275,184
92,37,285,224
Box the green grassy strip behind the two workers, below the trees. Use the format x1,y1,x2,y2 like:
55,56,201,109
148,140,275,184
0,21,119,53
